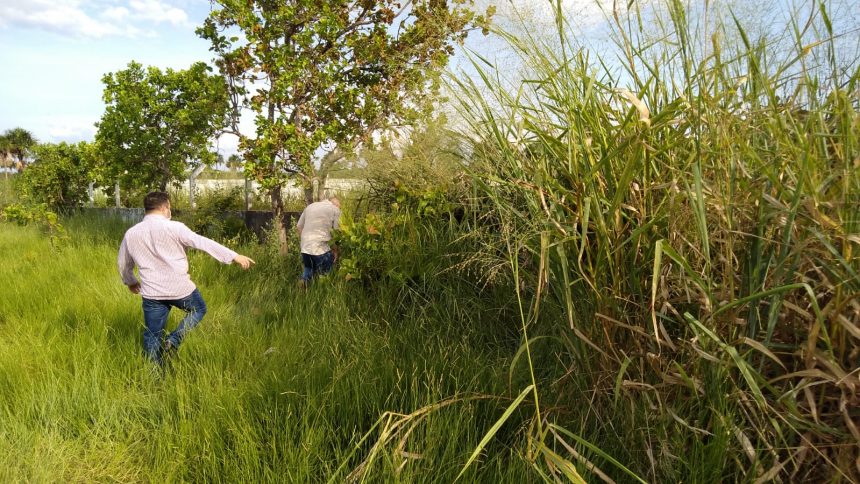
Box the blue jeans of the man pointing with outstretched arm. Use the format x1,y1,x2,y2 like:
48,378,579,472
143,289,206,363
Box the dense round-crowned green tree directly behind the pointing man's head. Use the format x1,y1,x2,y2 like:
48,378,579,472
96,62,228,191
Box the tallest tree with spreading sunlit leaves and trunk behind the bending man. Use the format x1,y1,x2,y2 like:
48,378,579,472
197,0,491,251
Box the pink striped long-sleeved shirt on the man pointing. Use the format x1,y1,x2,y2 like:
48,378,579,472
117,214,237,299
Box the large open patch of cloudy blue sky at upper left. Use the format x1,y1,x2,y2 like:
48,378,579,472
0,0,225,148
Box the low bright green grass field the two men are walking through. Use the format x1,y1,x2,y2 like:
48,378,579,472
0,217,529,482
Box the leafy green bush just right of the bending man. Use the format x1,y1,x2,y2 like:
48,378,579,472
335,122,470,284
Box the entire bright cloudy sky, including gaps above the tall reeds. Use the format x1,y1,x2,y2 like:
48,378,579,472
0,0,860,157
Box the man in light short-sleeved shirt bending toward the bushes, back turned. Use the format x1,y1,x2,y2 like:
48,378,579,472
296,197,340,284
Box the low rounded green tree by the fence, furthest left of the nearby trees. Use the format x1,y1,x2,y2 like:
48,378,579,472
18,141,95,209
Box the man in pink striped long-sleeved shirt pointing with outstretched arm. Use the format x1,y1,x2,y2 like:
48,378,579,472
117,192,254,364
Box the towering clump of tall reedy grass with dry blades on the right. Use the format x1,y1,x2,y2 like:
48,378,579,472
454,1,860,482
